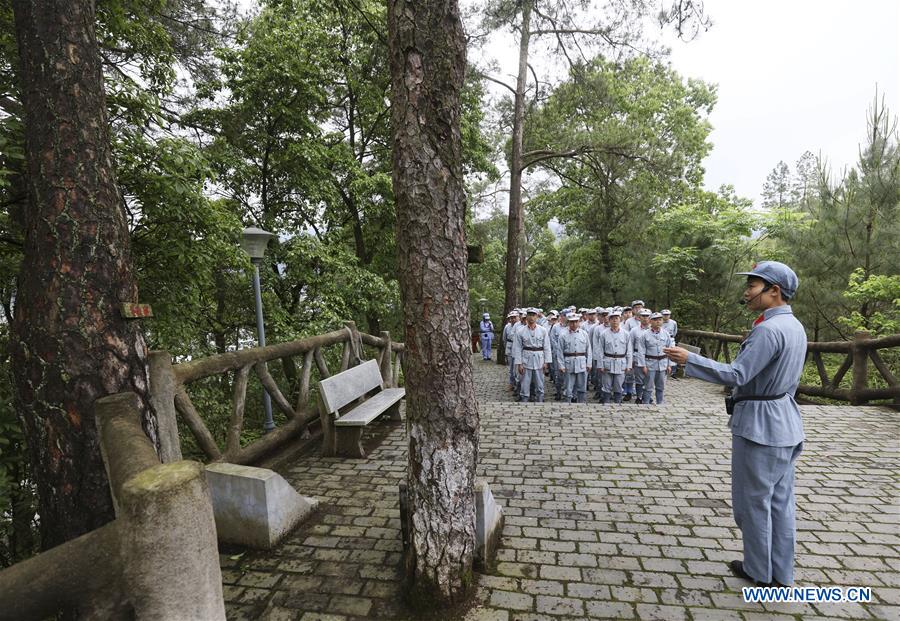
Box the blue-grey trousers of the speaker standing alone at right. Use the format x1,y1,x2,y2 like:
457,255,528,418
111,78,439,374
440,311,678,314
731,436,803,585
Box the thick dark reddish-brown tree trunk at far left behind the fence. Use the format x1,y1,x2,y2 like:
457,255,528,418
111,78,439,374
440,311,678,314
12,0,156,548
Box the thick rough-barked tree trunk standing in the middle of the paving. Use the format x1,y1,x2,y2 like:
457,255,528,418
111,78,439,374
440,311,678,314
388,0,478,605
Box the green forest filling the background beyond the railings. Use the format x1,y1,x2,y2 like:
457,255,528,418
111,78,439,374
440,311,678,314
0,0,900,567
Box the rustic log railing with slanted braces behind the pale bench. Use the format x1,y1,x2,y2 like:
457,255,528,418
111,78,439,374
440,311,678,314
150,321,405,465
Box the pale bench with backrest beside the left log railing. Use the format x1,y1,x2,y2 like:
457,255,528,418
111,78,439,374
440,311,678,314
319,360,406,457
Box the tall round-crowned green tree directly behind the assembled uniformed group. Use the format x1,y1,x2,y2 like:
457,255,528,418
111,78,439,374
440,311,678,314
525,58,715,302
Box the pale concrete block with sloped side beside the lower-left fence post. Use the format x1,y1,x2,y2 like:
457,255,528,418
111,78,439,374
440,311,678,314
206,463,318,549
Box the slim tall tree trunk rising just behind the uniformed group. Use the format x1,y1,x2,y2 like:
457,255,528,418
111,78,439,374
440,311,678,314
503,0,532,315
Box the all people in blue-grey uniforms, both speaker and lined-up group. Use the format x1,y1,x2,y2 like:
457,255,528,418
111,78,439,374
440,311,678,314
482,261,807,587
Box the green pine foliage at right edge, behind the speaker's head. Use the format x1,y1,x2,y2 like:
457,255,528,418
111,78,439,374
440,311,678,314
769,101,900,340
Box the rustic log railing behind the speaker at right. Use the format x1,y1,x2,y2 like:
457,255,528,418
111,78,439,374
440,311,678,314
678,330,900,405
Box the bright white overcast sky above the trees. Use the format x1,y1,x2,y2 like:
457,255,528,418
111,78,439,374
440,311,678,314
472,0,900,205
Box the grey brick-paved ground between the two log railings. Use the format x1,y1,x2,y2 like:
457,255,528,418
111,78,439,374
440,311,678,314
222,356,900,621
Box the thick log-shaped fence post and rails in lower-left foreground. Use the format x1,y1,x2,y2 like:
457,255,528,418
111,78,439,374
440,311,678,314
0,392,225,621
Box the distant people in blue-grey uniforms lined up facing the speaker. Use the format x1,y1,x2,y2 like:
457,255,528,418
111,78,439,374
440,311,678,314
481,300,678,404
